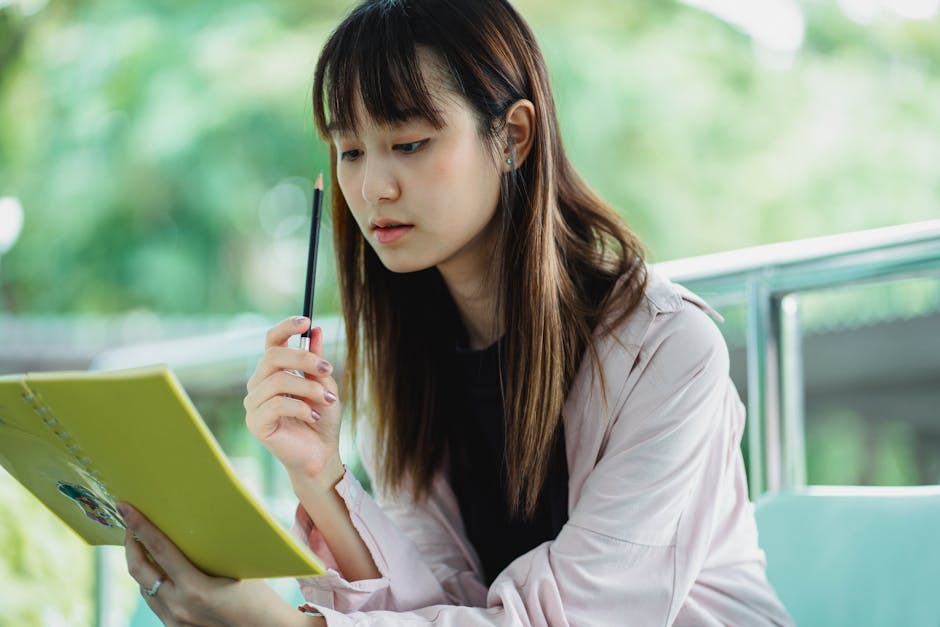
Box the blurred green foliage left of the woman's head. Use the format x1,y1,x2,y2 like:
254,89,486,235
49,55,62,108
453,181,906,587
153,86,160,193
0,2,348,313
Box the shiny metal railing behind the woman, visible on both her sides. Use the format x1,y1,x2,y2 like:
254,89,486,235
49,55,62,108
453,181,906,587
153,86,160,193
84,220,940,506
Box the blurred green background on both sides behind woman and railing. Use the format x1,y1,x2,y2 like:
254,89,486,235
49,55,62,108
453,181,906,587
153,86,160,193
0,0,940,626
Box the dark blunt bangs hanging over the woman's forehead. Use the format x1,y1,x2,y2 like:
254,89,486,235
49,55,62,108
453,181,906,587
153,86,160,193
313,0,444,138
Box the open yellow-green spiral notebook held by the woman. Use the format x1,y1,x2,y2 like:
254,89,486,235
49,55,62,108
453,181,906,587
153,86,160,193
0,367,324,579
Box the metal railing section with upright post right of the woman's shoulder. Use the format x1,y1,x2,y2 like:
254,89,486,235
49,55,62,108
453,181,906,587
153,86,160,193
656,220,940,498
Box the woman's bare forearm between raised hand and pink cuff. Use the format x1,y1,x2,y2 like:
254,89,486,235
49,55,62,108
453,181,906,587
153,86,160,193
291,458,381,581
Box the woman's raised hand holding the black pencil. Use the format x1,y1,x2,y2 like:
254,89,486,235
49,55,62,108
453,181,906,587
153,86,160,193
245,317,343,488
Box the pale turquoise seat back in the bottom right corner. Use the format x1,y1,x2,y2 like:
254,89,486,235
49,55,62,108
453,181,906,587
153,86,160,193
755,486,940,627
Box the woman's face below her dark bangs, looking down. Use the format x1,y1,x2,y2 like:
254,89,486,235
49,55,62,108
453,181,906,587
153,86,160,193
333,60,502,277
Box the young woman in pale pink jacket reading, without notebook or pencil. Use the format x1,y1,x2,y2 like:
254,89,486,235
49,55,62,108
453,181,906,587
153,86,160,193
122,0,790,626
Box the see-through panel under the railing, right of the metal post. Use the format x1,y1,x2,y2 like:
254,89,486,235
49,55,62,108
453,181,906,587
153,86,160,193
801,277,940,485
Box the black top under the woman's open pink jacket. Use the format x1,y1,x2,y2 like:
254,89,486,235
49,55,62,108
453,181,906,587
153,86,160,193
448,342,568,586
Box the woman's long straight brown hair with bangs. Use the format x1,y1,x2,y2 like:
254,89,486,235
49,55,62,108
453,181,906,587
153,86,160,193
313,0,646,515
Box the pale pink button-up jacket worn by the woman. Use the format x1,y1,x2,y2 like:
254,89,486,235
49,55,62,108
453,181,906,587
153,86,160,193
294,272,792,627
